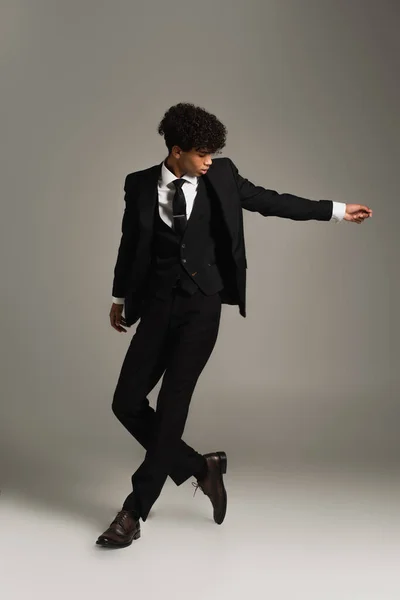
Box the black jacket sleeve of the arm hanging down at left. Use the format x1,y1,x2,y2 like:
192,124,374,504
111,173,138,298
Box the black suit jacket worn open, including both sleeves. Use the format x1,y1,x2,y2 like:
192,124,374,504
112,158,333,327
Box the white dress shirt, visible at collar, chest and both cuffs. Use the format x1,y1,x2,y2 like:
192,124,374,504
112,162,346,304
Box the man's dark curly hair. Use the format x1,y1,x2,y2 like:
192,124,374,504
158,102,227,154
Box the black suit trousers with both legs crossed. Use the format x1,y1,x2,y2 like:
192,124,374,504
112,288,221,521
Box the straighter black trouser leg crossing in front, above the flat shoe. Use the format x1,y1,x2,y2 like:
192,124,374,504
123,292,221,521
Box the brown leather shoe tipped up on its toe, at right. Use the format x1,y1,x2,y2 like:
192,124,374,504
192,452,227,525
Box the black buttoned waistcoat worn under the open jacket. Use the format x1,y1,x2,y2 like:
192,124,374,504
146,177,224,298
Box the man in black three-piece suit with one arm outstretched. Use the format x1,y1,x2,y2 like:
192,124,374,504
97,103,372,547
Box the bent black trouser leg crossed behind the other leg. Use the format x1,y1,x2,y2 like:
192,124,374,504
112,298,204,485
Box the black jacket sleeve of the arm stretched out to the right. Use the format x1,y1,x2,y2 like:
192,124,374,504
228,159,333,221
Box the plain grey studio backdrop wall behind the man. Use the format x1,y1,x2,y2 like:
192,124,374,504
0,0,400,512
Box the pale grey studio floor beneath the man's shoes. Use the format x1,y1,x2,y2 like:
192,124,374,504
0,457,400,600
